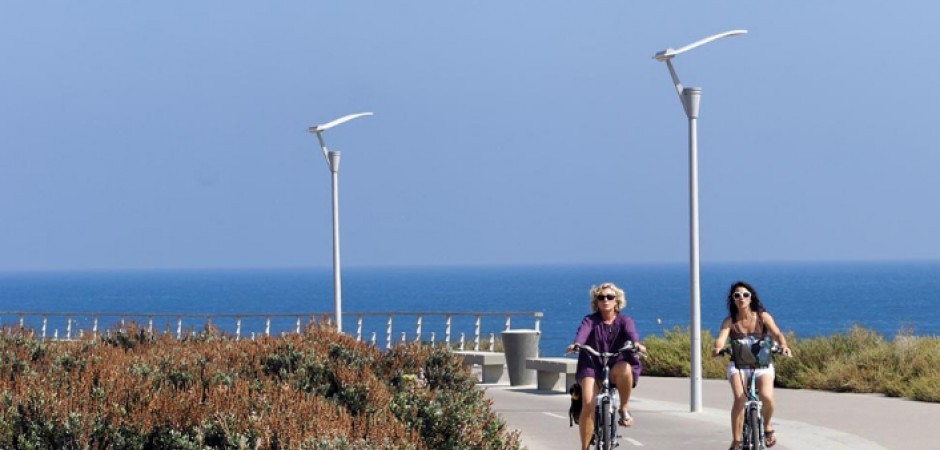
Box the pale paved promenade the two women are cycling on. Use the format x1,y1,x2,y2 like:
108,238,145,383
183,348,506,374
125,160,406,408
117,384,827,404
481,377,940,450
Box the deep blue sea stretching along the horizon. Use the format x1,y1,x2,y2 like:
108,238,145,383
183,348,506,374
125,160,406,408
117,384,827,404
0,261,940,356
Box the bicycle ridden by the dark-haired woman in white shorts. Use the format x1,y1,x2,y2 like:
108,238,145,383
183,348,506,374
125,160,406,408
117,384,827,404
718,339,782,450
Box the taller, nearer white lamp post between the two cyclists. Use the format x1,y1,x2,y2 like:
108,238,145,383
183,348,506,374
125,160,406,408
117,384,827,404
653,30,747,412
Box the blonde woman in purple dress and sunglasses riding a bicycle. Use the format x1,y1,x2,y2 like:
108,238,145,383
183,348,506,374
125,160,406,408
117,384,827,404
566,283,646,450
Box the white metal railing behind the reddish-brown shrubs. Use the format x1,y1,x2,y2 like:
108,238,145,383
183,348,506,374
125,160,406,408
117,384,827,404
0,311,542,350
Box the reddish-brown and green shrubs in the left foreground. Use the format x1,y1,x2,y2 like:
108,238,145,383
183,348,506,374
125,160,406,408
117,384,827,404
0,327,519,450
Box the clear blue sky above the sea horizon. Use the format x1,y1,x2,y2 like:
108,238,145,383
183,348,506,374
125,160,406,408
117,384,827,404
0,0,940,271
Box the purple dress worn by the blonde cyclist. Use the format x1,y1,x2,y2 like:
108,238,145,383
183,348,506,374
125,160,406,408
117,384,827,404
574,313,642,386
